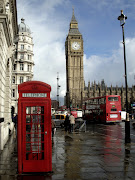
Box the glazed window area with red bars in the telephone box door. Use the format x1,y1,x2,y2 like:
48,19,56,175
26,106,44,160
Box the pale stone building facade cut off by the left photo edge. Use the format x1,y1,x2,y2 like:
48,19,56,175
0,0,18,150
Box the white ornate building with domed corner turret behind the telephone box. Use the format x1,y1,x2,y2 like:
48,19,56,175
11,18,34,115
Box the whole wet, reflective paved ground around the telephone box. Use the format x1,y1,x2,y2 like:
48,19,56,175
0,122,135,180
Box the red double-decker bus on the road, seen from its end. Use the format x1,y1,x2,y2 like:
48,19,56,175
83,95,121,123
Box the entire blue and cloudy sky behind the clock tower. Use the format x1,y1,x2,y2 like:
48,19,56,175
16,0,135,105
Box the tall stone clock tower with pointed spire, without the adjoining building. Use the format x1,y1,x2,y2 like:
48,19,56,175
65,10,84,108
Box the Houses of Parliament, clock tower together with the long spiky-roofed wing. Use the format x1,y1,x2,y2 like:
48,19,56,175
65,10,135,110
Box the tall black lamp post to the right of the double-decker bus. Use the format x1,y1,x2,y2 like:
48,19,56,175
118,10,131,143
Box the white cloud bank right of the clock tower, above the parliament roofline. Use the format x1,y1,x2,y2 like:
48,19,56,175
84,38,135,86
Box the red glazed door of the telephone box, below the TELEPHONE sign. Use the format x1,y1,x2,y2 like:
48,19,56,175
22,102,50,172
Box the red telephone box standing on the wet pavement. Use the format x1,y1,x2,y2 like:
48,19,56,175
17,81,52,173
